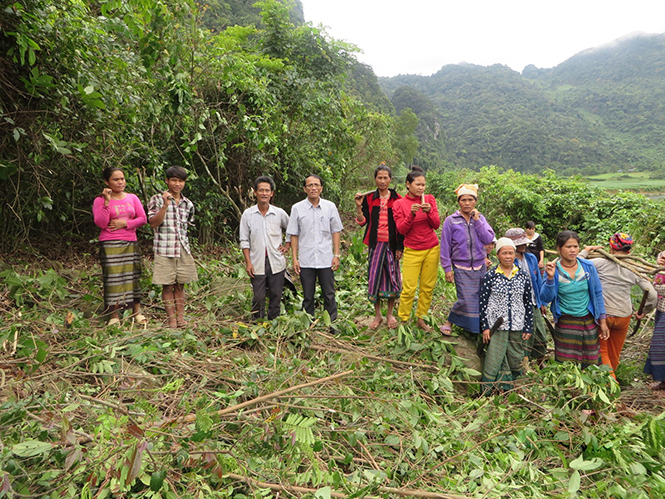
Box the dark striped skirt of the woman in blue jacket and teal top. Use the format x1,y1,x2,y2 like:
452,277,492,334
554,314,600,367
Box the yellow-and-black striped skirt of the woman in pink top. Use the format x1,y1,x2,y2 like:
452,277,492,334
99,241,142,310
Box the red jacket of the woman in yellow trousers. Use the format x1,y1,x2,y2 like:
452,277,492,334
393,194,441,250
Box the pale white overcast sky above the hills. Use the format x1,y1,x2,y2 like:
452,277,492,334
301,0,665,76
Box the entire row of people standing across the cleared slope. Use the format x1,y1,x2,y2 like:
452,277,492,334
93,164,665,390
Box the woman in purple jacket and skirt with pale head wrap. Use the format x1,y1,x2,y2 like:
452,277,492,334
441,184,494,336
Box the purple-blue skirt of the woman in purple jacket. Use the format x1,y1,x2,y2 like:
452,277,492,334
448,265,487,334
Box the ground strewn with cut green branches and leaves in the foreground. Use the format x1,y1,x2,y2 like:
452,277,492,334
0,236,665,499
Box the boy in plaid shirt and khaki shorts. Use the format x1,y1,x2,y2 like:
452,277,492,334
148,166,198,329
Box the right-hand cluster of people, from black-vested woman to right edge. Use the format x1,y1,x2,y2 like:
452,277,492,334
355,165,665,391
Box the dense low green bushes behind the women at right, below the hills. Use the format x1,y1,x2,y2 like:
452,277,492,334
427,166,665,256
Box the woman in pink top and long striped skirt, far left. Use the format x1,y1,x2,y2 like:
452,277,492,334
92,167,148,326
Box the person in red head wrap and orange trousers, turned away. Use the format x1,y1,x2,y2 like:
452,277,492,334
580,232,658,378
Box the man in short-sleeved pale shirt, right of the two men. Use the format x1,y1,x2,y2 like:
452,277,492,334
286,175,342,321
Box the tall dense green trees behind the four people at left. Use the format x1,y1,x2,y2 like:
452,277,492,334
0,0,399,250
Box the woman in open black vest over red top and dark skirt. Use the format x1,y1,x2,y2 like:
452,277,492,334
355,163,404,330
